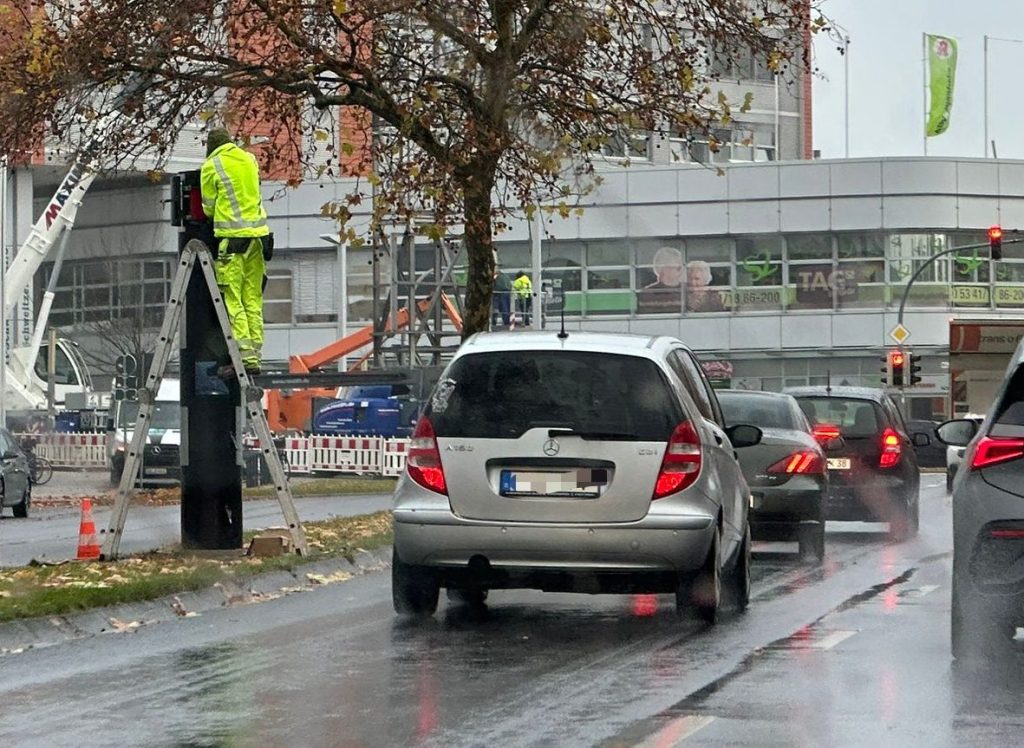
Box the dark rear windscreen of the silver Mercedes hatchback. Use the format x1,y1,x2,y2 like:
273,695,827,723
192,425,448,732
426,350,682,442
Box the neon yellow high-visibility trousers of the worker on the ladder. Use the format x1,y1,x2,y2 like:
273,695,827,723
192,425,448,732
214,239,266,367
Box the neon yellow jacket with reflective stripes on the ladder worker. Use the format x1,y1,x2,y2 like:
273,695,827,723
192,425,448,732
201,142,270,239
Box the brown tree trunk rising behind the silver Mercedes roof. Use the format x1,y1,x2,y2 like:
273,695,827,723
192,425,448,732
462,161,496,340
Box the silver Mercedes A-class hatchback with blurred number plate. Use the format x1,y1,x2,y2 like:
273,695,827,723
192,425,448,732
392,331,761,622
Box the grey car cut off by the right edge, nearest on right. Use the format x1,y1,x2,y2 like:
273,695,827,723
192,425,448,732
937,342,1024,659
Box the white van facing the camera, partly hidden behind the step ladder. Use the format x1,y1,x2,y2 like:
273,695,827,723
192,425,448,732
106,378,181,487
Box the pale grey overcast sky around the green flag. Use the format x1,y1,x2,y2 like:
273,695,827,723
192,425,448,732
814,0,1024,159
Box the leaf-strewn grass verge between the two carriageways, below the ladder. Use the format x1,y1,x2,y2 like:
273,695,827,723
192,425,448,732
0,511,391,622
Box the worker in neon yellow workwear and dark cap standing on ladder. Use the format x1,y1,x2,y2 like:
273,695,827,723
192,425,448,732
200,127,271,376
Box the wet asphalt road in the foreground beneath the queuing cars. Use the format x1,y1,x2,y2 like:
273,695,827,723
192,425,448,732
0,475,1024,748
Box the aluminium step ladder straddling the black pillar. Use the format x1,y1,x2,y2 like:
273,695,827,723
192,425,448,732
99,239,308,560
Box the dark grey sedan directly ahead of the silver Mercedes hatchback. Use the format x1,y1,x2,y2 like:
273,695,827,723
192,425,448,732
718,389,828,564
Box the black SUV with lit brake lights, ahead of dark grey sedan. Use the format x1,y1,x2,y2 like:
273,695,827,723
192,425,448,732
784,386,930,540
